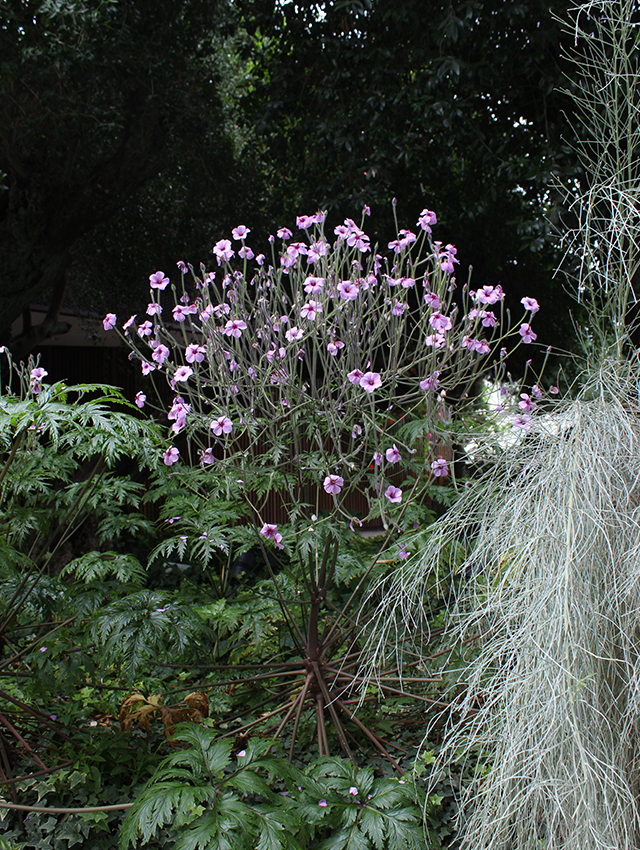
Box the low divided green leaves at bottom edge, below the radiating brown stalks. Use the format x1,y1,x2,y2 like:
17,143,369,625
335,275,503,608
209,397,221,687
120,724,438,850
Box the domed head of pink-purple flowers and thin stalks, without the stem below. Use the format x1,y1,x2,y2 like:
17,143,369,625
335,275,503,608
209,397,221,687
103,209,539,548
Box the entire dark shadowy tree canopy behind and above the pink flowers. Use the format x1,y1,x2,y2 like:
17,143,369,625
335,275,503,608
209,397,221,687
0,0,576,362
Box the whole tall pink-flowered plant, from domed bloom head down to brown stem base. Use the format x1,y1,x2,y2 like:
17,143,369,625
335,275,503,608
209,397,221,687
104,208,538,764
